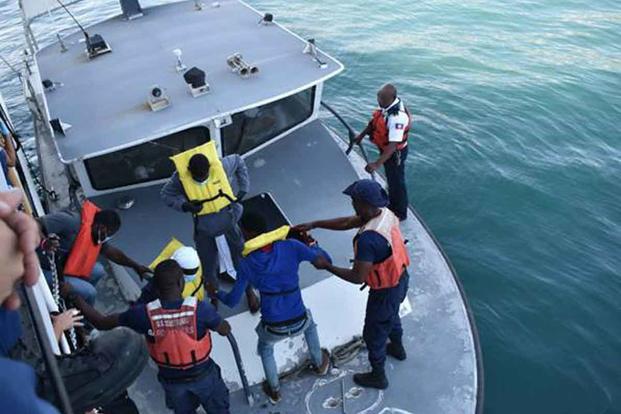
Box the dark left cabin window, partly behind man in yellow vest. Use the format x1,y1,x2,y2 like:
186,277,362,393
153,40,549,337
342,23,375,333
84,127,209,190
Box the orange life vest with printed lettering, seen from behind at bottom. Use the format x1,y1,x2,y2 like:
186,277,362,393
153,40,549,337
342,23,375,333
147,296,211,369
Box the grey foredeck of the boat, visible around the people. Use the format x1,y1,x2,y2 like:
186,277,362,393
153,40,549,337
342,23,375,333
96,121,482,414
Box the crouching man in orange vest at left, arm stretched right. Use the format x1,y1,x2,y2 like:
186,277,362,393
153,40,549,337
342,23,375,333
38,200,151,304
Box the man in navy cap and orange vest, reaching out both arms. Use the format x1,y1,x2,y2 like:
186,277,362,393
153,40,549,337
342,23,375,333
297,180,410,389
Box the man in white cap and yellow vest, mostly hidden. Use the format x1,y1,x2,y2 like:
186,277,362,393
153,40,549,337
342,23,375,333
136,238,205,303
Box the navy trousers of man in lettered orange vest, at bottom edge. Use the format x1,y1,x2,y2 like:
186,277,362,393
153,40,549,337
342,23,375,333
160,361,229,414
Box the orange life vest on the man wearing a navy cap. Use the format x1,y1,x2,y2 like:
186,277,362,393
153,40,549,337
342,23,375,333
354,208,410,289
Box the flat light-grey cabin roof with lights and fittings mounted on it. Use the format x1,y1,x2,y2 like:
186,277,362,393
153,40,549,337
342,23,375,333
37,0,343,162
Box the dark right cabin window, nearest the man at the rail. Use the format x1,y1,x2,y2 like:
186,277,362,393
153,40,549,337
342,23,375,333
221,87,315,154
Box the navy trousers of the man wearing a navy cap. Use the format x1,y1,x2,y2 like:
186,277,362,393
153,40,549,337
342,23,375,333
362,270,410,369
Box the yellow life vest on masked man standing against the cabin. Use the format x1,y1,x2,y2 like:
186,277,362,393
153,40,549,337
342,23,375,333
170,141,235,216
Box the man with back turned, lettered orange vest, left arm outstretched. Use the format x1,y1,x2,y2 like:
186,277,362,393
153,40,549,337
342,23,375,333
63,259,231,414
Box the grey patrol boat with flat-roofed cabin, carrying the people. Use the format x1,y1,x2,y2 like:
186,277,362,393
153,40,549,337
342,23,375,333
10,0,483,414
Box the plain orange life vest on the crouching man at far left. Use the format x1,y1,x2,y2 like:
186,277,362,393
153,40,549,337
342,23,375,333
63,200,101,279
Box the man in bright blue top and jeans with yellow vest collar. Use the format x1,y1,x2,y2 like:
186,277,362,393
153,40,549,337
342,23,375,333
207,214,330,404
